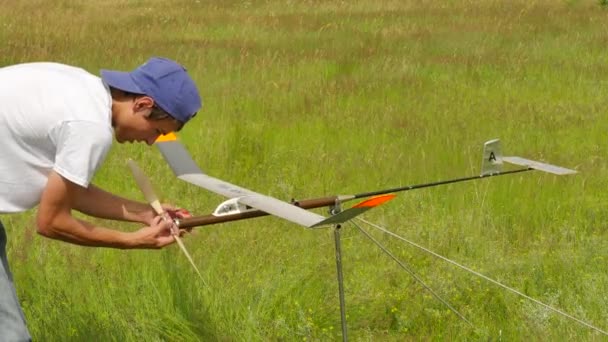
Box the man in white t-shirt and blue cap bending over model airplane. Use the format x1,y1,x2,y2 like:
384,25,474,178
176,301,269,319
0,57,201,341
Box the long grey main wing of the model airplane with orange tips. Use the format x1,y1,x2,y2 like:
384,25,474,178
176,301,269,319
156,133,392,228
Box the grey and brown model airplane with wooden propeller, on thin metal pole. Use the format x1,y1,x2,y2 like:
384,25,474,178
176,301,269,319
130,133,576,341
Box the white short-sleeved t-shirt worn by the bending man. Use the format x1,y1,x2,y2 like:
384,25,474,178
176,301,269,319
0,63,113,213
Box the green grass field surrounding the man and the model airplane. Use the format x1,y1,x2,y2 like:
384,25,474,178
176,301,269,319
0,0,608,341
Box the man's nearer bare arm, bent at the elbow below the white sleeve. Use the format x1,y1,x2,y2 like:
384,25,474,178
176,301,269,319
37,172,174,248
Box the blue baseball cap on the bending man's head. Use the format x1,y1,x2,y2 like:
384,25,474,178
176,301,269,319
101,57,202,123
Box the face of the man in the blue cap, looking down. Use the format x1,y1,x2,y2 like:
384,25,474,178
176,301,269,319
113,96,180,145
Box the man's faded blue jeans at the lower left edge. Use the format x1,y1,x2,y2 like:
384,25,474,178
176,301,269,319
0,221,32,342
